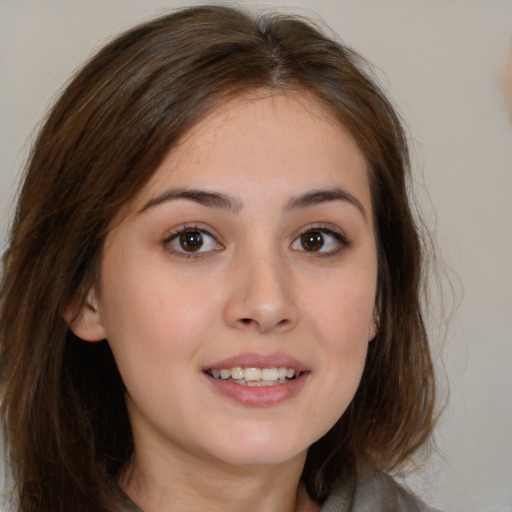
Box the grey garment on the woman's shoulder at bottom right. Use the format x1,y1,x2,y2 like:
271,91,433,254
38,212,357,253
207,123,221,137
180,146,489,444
321,473,438,512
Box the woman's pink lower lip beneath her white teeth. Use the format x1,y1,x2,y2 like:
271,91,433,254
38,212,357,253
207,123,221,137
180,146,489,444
203,372,309,407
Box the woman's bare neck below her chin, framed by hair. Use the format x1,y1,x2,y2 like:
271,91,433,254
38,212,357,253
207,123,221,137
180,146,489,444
119,442,318,512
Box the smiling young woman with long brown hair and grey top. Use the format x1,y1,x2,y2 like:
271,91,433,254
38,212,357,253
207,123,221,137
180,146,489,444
0,6,440,512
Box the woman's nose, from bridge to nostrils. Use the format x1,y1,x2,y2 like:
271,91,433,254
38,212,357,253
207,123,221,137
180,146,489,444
225,250,299,334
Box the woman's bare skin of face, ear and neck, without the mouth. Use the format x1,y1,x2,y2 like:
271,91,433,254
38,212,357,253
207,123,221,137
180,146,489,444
72,92,377,512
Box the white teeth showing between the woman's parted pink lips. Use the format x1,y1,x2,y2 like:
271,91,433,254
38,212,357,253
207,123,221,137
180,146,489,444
205,366,302,386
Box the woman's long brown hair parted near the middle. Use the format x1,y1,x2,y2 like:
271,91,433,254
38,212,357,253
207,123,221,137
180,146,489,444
0,6,434,512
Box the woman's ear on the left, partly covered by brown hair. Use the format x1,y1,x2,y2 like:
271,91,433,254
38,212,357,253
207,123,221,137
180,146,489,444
62,289,106,342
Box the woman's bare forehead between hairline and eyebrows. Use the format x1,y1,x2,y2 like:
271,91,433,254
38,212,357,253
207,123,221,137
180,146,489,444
126,91,370,213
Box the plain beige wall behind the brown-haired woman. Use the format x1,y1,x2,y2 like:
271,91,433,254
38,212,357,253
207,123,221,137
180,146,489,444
0,0,512,512
